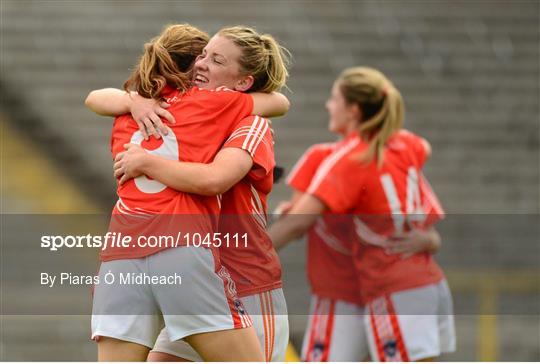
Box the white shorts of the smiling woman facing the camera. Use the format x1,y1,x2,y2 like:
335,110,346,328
152,288,289,362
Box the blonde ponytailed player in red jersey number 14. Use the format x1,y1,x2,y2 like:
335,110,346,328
269,67,455,361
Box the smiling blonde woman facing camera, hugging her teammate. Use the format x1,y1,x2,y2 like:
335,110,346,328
87,26,289,361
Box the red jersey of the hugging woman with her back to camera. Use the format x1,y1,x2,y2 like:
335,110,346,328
101,87,253,261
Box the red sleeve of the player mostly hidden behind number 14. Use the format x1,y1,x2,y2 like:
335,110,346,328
287,143,334,192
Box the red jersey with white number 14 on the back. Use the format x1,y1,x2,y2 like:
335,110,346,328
308,130,443,302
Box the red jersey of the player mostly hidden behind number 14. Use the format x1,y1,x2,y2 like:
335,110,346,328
287,142,360,303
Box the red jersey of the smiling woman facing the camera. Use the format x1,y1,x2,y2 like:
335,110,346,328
219,116,282,297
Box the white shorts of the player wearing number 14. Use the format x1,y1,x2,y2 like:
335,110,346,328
365,280,456,362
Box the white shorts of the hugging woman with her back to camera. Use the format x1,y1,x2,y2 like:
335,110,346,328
92,247,251,348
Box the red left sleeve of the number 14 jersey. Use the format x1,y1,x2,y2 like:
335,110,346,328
307,139,363,214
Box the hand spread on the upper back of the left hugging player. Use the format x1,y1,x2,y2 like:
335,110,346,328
130,93,176,140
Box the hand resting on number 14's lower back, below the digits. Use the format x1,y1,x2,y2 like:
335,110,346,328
385,229,440,259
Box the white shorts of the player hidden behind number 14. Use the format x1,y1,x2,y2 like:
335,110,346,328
302,295,369,362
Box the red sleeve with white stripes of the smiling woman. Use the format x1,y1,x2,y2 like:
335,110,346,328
223,116,276,178
